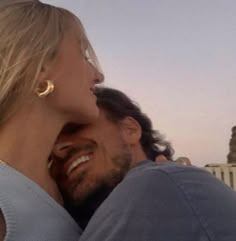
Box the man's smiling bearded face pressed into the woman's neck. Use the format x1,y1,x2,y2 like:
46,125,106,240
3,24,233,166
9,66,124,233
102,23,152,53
51,111,132,205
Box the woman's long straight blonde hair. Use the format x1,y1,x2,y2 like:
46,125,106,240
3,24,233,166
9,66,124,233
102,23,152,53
0,0,96,124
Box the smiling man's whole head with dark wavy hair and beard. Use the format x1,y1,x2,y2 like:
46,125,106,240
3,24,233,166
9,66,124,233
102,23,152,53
51,88,174,228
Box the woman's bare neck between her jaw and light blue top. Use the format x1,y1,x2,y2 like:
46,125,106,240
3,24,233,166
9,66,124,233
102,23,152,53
0,106,63,203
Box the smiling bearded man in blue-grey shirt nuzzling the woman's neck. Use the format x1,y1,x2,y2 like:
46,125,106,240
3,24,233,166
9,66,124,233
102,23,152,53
52,88,236,241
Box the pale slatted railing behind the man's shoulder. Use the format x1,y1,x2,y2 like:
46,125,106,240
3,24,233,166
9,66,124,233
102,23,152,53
204,164,236,191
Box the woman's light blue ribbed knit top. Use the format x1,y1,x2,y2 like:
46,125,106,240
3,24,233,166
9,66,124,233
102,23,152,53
0,164,82,241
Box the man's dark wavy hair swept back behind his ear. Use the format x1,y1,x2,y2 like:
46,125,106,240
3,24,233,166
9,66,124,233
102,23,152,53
95,87,174,160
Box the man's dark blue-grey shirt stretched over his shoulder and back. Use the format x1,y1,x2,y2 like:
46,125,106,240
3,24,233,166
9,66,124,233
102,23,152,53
82,161,236,241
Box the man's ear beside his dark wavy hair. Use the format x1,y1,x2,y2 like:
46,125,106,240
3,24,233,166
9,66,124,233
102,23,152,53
121,116,142,145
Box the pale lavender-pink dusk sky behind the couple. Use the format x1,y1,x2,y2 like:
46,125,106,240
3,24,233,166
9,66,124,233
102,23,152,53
44,0,236,166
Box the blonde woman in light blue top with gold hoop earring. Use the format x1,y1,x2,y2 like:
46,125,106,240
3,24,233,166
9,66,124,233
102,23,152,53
0,0,103,241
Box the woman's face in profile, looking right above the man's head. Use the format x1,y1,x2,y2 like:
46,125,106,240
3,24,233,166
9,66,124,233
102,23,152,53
48,20,104,123
